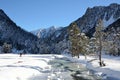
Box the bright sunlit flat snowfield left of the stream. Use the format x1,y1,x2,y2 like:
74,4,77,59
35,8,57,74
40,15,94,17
0,54,55,80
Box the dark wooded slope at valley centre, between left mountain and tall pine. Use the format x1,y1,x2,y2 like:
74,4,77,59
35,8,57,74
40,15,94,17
34,27,68,54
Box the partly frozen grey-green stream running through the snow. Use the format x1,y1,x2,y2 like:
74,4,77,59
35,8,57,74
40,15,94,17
48,57,101,80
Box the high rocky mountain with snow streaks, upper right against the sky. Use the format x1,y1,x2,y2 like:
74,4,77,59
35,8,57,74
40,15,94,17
75,3,120,34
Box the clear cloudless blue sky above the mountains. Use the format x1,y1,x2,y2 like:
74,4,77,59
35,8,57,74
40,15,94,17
0,0,120,31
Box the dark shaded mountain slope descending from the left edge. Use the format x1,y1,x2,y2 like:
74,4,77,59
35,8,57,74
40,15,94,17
0,9,37,52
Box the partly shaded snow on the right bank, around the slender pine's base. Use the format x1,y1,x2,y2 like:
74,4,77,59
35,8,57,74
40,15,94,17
65,55,120,80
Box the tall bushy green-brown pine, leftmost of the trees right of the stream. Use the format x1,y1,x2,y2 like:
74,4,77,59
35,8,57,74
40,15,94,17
68,23,81,58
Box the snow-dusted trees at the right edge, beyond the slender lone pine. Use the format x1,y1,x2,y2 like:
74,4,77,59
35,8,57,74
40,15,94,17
104,27,120,56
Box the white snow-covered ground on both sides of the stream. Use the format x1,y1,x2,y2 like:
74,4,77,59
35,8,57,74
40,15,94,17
0,54,120,80
